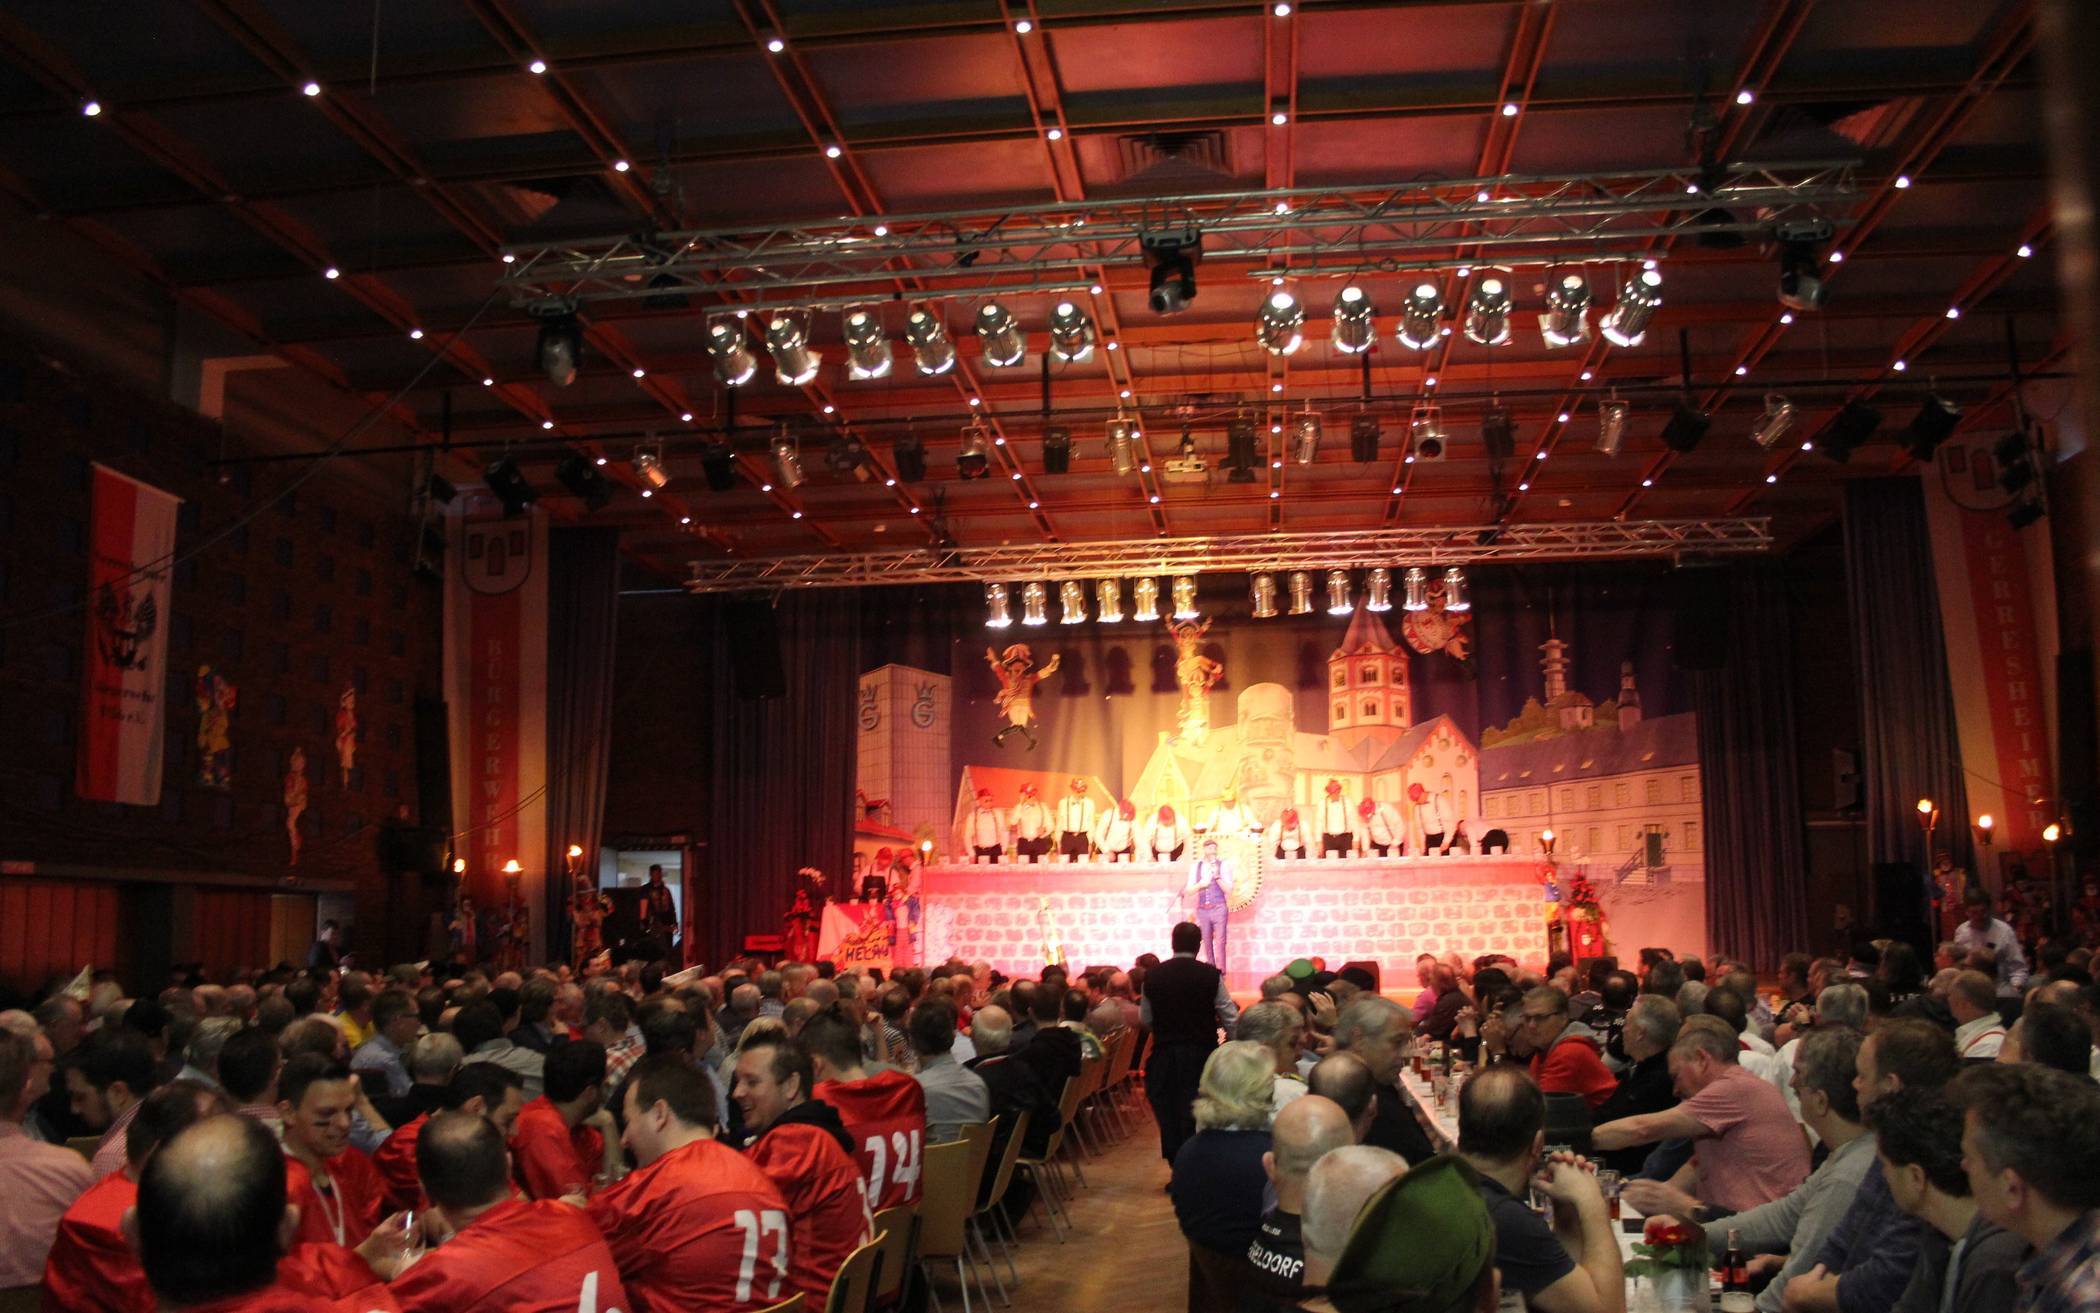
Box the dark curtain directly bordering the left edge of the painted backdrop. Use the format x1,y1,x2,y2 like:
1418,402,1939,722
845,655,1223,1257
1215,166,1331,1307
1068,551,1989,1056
695,588,863,962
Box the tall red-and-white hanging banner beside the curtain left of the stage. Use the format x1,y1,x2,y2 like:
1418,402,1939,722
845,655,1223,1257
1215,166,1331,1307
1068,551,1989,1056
445,492,548,962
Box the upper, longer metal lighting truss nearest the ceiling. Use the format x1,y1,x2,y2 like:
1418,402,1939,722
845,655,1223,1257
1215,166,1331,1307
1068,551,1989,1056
500,160,1859,309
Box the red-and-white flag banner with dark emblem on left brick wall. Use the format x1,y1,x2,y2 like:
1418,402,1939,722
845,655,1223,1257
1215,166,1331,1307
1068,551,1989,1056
74,464,183,807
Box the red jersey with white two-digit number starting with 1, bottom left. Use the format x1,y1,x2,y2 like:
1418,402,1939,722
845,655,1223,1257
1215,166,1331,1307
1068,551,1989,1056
590,1141,792,1313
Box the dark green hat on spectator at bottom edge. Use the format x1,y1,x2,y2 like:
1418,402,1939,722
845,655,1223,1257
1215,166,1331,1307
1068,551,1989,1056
1327,1153,1495,1313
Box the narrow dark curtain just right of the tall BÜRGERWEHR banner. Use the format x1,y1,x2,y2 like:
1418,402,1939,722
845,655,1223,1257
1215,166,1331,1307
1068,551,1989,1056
544,529,620,958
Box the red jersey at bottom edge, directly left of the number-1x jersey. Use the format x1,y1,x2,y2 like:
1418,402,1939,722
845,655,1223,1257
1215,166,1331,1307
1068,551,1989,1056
393,1200,634,1313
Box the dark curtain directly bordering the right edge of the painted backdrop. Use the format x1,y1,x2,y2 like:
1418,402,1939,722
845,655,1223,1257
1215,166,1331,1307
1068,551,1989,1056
1693,561,1808,966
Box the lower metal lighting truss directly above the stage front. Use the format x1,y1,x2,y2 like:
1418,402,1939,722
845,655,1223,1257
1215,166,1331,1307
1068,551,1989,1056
685,517,1772,592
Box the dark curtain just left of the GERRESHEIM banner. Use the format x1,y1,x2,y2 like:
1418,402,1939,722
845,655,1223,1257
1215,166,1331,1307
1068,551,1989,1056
1844,479,1972,899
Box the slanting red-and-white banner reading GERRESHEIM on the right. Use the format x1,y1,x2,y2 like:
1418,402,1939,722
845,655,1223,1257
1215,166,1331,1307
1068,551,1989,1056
1926,433,2058,853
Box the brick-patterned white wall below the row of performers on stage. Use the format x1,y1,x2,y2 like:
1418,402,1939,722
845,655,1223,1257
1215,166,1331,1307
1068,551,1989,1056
924,857,1546,989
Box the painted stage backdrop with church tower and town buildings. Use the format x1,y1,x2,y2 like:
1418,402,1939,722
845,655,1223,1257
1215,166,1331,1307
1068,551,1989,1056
872,565,1705,966
